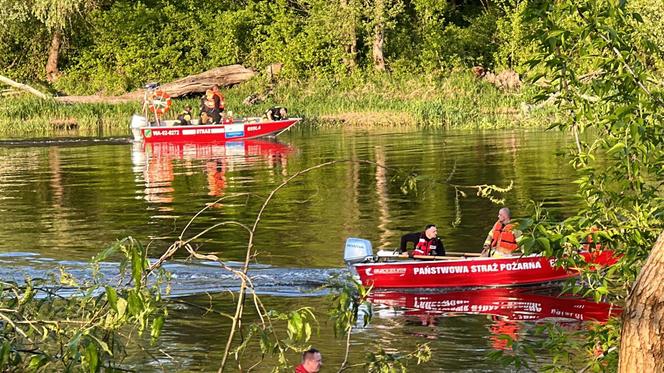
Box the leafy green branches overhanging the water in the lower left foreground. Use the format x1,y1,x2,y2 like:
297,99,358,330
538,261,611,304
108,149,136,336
0,238,166,372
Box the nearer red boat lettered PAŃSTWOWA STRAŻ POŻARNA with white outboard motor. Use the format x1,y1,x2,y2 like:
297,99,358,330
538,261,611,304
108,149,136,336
344,238,617,289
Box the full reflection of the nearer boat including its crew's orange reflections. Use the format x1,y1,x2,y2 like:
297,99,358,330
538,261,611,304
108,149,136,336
370,288,622,350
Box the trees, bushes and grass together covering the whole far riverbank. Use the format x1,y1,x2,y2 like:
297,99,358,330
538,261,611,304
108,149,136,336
0,0,664,135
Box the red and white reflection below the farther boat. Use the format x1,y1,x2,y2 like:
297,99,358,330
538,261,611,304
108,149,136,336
132,140,293,206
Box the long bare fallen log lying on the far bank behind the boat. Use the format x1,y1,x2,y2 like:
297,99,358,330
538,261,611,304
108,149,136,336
55,65,256,104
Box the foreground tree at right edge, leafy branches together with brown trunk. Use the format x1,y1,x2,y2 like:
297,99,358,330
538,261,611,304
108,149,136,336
524,0,664,371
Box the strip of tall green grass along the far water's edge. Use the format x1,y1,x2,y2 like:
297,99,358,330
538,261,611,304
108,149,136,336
0,73,551,138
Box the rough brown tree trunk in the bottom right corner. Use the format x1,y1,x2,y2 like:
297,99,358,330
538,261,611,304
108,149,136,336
618,232,664,373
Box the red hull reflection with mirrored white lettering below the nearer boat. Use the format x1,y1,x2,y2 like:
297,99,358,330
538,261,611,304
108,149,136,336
370,288,622,322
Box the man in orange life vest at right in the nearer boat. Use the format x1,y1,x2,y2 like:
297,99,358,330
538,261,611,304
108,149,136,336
482,207,521,258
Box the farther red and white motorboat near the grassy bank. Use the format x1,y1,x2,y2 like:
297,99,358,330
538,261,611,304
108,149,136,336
131,115,301,143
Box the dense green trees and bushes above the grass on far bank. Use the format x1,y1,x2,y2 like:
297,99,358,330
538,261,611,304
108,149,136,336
0,0,664,94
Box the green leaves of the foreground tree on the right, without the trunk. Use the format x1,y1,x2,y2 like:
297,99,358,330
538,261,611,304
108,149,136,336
490,0,664,371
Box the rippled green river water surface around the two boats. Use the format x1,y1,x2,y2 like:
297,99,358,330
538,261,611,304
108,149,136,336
0,126,616,371
